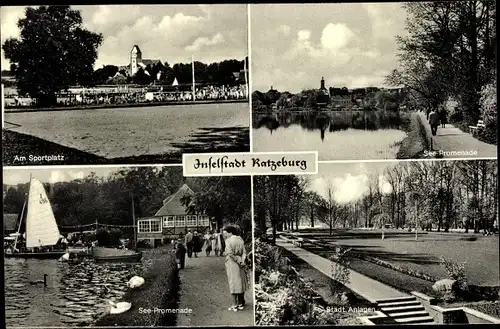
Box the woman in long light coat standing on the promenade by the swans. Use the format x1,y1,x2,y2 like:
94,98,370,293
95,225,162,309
223,226,249,312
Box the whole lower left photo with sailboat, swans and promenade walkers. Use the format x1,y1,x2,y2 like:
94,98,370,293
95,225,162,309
3,166,254,328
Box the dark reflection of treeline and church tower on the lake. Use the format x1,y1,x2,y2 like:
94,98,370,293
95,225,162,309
252,111,405,141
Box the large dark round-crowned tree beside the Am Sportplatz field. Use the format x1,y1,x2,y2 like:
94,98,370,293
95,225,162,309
2,6,102,106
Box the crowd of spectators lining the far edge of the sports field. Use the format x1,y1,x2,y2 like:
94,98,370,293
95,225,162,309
4,85,247,107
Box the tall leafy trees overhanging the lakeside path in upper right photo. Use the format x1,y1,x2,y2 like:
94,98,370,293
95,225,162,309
387,1,496,127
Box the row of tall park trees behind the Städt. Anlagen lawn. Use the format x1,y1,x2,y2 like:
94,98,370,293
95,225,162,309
254,160,498,243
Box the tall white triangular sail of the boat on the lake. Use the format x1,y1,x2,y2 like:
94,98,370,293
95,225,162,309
26,178,61,248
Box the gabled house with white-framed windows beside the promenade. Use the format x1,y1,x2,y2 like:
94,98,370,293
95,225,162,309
137,184,213,246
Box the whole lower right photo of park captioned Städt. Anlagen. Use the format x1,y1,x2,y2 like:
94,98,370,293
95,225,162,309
253,160,500,325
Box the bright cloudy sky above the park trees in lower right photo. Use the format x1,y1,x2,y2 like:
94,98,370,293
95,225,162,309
308,162,397,203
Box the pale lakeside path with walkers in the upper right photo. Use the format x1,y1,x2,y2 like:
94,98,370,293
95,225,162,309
418,112,497,158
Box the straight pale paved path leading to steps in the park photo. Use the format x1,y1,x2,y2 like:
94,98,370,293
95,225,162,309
276,239,408,303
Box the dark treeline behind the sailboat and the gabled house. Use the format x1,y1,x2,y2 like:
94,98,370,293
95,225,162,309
4,167,251,240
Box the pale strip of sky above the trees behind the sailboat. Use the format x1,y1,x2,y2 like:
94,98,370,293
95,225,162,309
3,167,120,185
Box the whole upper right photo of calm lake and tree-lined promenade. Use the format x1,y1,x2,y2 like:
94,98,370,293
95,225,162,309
250,1,497,161
